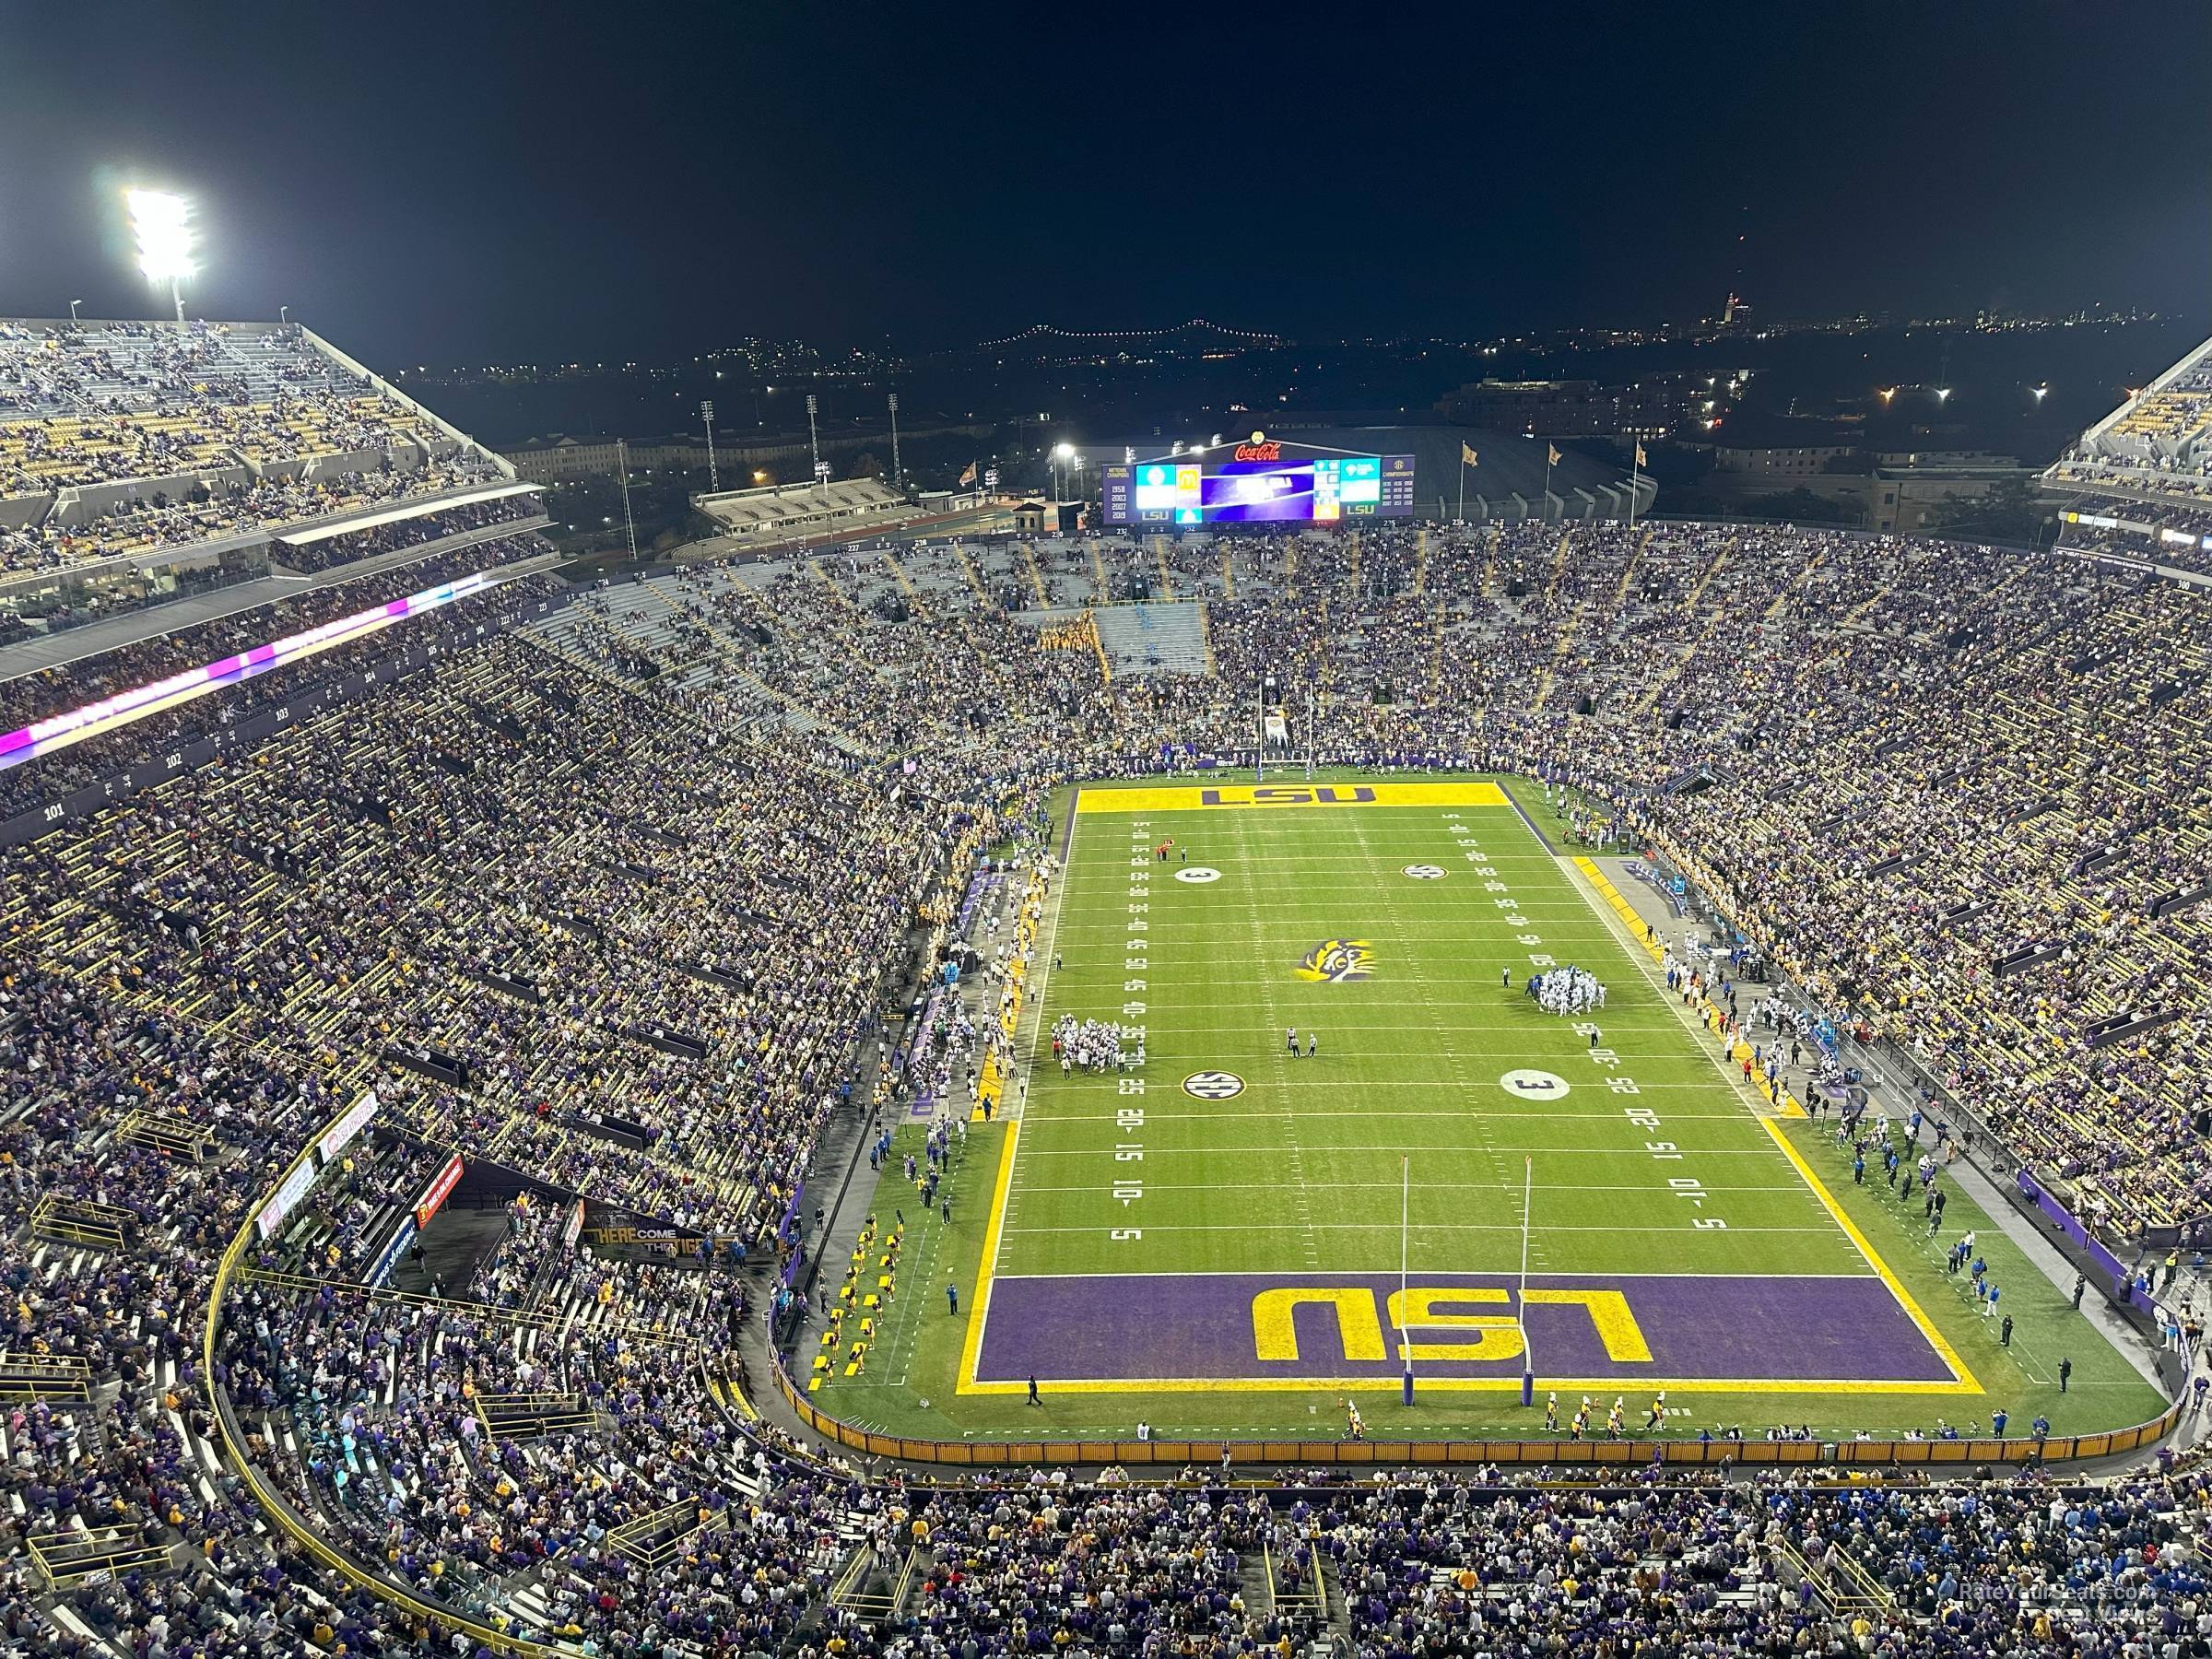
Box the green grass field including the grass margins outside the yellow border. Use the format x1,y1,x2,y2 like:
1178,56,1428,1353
817,779,2161,1438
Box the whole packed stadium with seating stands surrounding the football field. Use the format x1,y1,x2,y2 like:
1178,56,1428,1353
0,299,2212,1654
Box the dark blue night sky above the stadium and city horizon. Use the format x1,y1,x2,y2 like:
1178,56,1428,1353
0,0,2212,367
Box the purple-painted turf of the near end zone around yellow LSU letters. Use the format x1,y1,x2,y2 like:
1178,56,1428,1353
975,1272,1953,1384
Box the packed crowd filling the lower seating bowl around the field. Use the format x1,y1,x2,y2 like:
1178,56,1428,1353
0,512,2212,1659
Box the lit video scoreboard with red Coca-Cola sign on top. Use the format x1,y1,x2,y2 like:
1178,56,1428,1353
1101,442,1414,524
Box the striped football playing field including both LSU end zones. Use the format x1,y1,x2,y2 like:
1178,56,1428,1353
964,783,1978,1392
